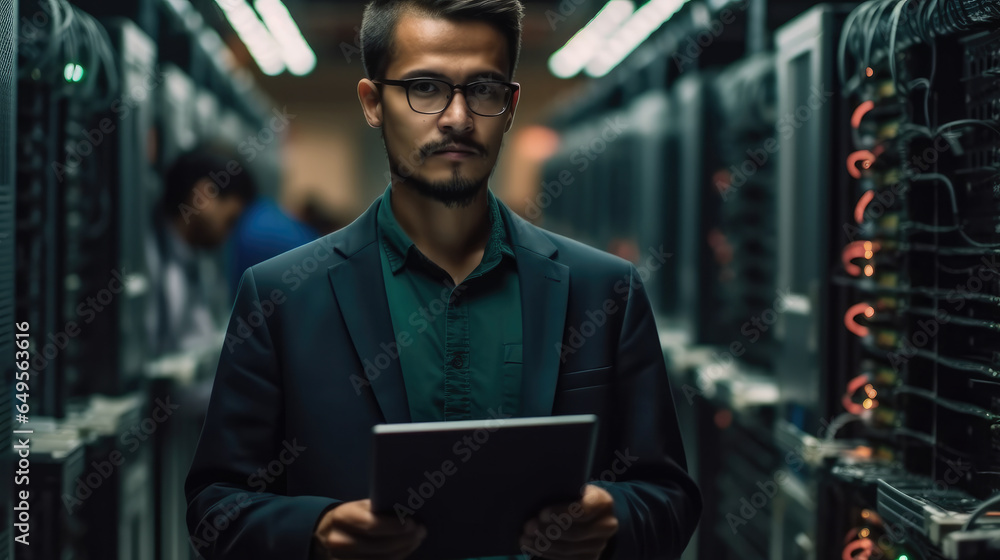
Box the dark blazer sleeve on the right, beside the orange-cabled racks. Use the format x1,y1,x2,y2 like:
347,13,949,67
594,264,702,560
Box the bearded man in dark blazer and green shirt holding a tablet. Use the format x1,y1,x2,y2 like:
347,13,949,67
186,0,701,560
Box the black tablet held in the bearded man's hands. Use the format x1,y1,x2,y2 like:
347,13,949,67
371,414,597,560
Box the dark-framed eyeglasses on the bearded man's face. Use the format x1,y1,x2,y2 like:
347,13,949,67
372,78,521,117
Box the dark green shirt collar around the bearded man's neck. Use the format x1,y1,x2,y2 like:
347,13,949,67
376,184,514,274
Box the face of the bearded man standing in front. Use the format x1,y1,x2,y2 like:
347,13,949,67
358,13,517,207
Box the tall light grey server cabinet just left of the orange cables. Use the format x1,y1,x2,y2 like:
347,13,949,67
774,5,850,440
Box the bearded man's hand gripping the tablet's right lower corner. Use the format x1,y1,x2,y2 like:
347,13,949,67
521,484,618,560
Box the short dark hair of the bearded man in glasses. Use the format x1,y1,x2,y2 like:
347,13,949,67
361,0,524,80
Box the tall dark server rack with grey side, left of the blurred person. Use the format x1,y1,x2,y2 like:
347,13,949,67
67,18,161,398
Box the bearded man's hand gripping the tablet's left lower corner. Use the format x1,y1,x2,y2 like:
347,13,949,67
312,500,427,560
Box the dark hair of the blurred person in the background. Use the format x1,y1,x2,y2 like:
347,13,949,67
160,143,257,216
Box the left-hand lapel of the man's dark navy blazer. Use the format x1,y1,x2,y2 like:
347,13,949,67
327,198,410,424
